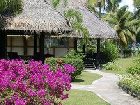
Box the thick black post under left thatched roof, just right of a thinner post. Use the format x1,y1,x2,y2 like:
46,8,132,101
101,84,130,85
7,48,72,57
39,32,45,63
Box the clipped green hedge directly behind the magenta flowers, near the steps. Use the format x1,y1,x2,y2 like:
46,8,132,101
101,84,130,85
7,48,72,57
46,58,84,79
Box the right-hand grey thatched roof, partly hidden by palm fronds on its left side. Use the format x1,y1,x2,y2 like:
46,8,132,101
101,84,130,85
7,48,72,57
54,0,117,38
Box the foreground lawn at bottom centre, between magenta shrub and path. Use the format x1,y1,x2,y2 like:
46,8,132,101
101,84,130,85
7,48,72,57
63,90,110,105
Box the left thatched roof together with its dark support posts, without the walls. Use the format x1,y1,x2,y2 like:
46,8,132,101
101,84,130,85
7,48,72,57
0,0,71,61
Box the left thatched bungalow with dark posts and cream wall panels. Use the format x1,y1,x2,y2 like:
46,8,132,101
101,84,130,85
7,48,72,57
0,0,72,59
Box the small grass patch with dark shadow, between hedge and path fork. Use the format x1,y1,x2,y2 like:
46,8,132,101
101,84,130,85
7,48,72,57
72,71,102,85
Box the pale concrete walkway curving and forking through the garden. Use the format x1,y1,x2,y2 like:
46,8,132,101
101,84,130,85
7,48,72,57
72,70,140,105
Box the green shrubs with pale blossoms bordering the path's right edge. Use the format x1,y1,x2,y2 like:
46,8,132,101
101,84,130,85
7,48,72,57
119,57,140,99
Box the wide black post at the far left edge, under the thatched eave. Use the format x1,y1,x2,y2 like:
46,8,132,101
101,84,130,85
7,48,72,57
0,30,7,59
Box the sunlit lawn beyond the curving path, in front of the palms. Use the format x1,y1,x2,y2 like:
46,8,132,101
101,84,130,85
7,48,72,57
105,57,137,74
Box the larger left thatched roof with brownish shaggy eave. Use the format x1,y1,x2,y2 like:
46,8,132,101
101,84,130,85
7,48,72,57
1,0,71,32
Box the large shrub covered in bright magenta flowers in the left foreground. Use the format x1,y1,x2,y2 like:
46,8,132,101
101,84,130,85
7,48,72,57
0,60,75,105
